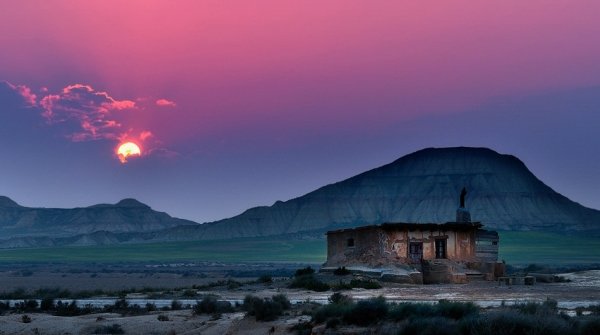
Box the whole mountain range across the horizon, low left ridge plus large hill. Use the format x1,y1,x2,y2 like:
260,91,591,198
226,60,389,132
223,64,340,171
0,147,600,247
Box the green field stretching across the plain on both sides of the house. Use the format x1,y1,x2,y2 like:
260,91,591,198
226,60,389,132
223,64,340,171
0,232,600,265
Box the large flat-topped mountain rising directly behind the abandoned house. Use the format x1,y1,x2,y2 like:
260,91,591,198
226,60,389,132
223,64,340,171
185,147,600,238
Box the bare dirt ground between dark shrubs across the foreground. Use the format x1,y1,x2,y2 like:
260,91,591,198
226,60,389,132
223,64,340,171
0,265,600,334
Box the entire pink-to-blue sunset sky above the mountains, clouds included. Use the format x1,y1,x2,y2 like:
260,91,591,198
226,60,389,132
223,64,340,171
0,0,600,222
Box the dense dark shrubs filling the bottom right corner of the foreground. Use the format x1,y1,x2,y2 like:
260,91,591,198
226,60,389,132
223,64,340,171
312,292,600,335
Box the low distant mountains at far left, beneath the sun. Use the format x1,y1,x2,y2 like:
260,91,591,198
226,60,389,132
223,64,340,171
0,196,196,240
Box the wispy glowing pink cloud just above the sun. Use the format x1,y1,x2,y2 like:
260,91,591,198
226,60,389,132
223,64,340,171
4,82,176,163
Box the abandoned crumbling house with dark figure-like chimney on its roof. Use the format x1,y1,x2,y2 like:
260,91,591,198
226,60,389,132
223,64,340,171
323,189,504,284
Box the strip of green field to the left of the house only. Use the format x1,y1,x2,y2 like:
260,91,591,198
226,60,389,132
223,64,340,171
0,238,326,263
